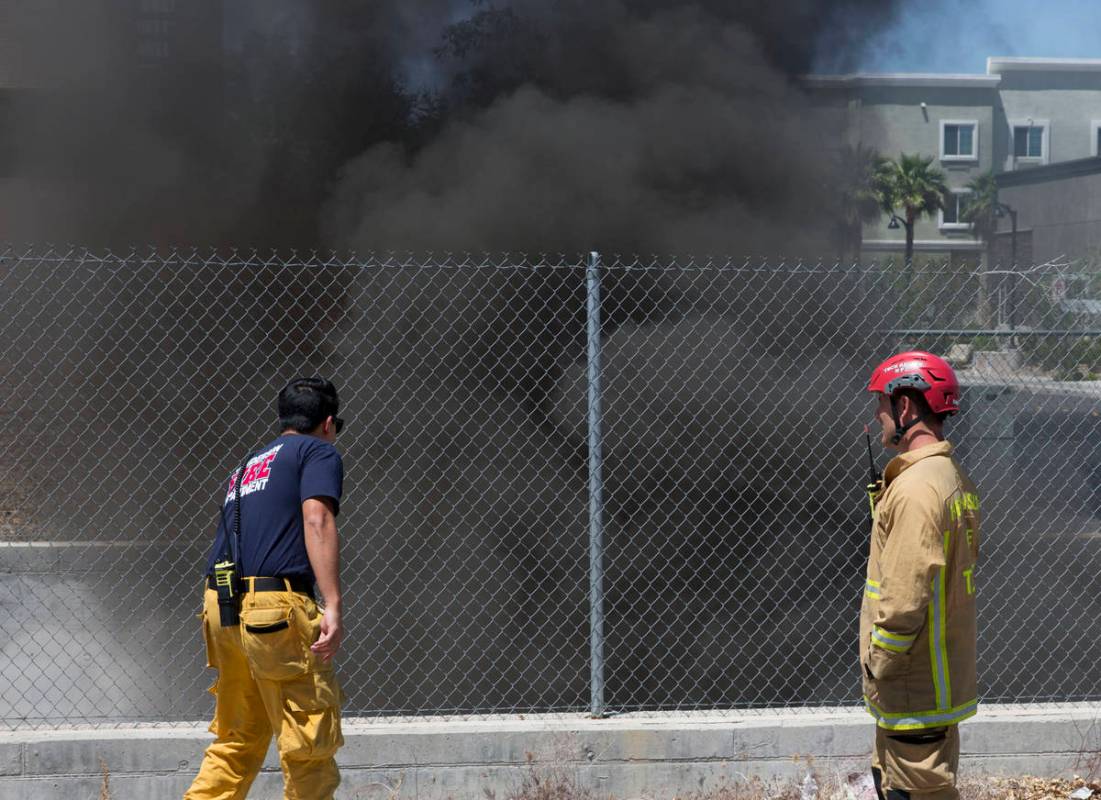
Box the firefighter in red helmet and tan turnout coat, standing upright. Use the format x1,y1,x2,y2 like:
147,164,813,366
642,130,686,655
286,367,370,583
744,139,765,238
860,351,979,800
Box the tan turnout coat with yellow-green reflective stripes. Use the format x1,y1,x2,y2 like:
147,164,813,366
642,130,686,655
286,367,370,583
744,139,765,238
860,441,979,731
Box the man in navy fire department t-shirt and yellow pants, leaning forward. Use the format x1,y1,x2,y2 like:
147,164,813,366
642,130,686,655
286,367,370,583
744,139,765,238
185,377,344,800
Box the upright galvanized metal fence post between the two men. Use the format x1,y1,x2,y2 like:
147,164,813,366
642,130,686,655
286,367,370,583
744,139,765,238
585,251,604,717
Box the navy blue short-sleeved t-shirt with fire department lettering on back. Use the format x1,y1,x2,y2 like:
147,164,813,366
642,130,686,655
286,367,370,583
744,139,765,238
207,434,344,580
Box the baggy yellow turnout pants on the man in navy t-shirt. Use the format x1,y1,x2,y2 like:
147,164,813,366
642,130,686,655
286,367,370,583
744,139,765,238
184,579,344,800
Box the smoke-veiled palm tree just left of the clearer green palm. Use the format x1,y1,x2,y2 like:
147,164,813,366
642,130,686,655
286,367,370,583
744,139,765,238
832,144,887,262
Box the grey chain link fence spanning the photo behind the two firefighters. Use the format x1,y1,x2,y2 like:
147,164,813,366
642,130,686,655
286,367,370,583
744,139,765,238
0,248,1101,727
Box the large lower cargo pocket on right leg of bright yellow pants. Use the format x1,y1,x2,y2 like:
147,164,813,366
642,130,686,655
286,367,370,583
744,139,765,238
279,672,344,760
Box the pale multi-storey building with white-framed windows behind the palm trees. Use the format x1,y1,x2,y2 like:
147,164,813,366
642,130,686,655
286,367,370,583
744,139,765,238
805,58,1101,259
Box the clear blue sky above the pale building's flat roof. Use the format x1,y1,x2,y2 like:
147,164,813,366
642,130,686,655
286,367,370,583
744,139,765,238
860,0,1101,74
